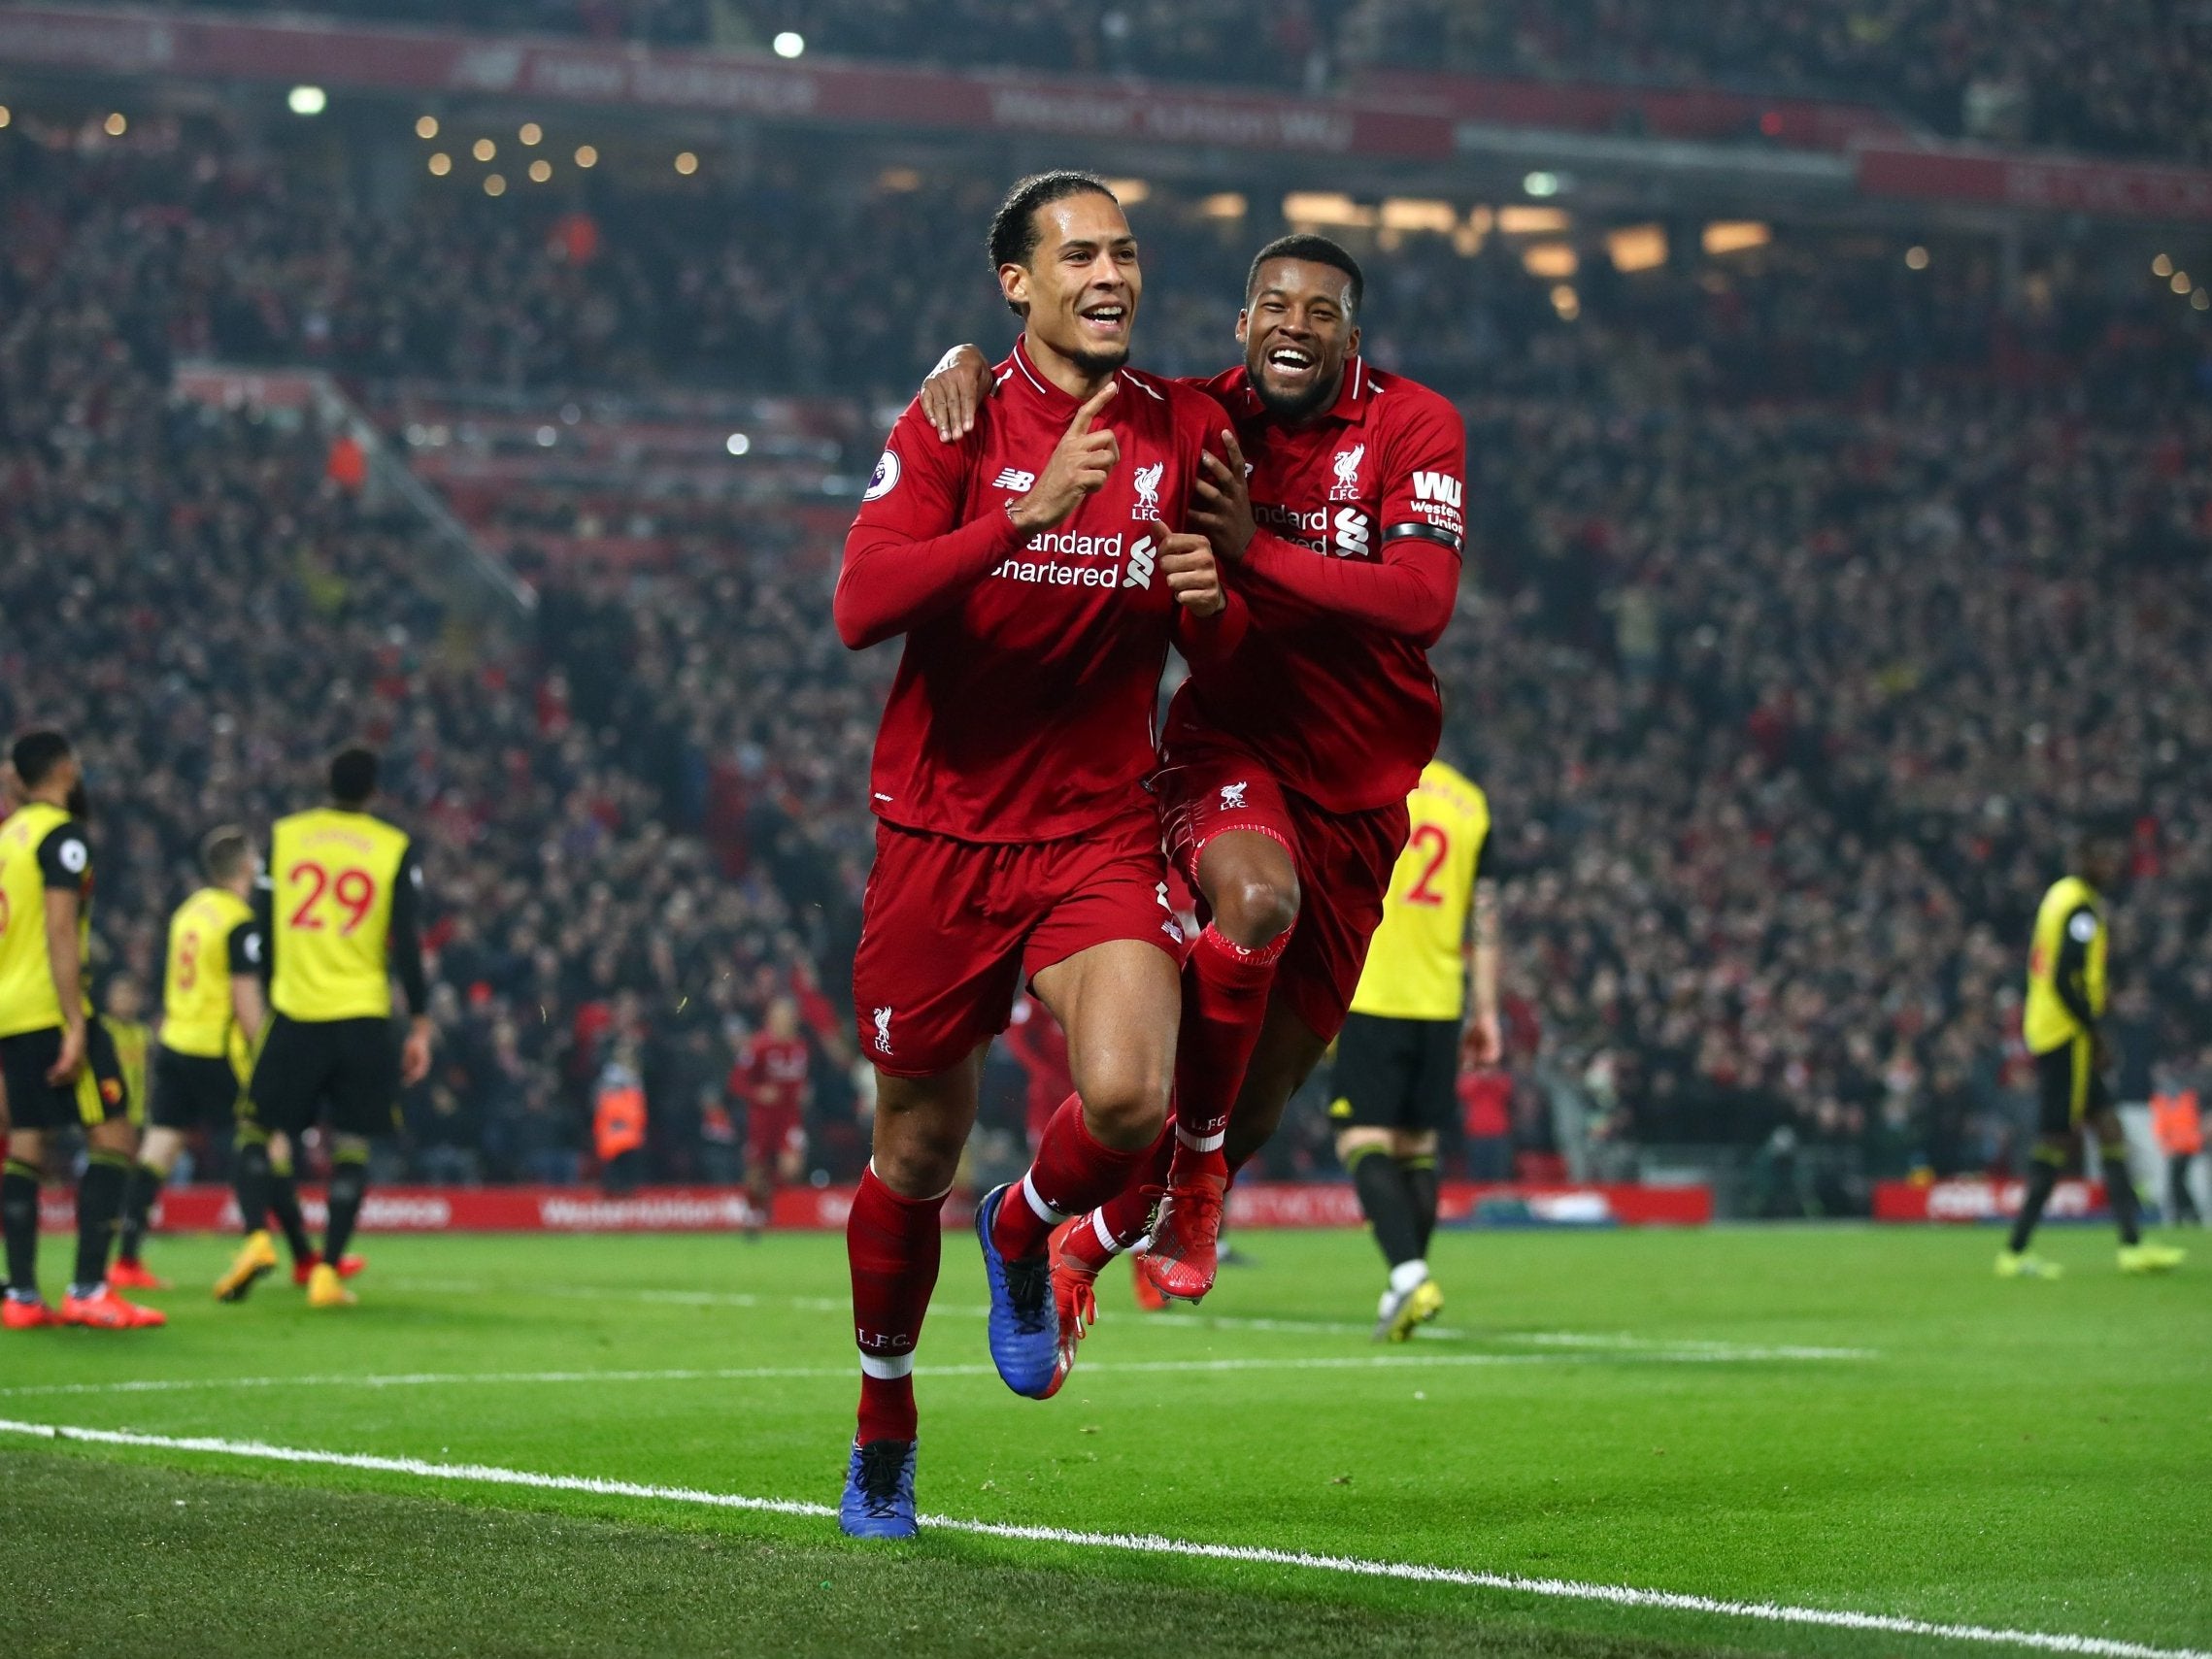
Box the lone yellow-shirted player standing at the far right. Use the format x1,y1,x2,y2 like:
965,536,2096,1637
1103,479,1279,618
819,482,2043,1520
1997,830,2186,1278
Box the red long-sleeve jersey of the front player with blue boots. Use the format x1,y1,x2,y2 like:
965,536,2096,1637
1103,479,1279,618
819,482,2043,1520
836,343,1236,841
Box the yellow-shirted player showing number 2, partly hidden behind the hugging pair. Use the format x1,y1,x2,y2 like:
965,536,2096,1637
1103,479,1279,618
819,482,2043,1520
1329,761,1502,1343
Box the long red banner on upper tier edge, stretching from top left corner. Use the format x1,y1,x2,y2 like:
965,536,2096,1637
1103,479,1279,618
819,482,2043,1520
0,7,1451,159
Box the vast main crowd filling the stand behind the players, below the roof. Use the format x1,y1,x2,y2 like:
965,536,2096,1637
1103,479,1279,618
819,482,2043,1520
0,119,2212,1211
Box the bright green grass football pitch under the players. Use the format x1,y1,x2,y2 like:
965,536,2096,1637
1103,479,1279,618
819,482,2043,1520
0,1228,2212,1659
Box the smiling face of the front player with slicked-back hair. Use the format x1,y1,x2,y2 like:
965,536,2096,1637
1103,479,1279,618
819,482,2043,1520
997,190,1144,381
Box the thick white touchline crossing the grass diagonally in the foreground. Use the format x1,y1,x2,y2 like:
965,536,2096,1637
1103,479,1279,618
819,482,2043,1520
0,1418,2212,1659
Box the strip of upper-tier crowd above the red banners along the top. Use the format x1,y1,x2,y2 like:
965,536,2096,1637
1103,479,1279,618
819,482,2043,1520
104,0,2212,161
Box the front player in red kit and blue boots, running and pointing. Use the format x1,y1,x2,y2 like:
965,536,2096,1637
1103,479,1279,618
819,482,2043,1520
836,173,1239,1538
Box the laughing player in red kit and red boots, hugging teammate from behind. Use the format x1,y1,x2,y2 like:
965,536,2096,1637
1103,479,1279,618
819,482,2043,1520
922,235,1466,1365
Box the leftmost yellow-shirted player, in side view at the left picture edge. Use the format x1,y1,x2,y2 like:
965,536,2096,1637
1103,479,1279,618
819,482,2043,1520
0,730,168,1332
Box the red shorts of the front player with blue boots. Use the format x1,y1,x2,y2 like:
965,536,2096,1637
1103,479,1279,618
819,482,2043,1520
852,805,1184,1078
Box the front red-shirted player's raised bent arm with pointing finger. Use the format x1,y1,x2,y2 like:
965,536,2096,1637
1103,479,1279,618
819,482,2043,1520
832,381,1122,650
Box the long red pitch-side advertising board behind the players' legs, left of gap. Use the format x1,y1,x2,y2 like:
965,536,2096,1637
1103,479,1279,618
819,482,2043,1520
40,1181,1712,1232
